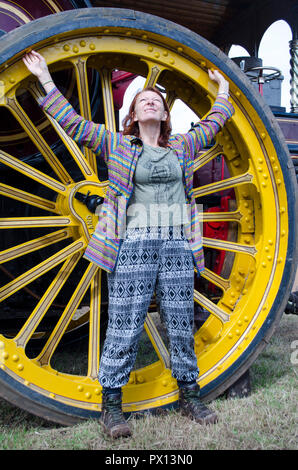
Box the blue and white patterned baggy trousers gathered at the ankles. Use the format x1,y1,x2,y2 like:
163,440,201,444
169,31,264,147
98,227,199,388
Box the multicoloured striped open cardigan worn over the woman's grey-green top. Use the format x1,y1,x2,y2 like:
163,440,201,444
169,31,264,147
40,88,234,274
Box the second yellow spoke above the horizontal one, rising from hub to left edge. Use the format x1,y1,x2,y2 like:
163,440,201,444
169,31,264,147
0,151,66,193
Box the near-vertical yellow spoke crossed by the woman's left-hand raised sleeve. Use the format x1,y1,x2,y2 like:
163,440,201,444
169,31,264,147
72,57,97,173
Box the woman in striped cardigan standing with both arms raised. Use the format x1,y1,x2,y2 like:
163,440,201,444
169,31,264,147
23,51,234,437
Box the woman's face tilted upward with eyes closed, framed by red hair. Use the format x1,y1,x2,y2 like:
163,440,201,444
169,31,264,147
134,90,168,123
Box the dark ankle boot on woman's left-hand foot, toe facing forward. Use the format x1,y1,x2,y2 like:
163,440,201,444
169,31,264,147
101,392,131,438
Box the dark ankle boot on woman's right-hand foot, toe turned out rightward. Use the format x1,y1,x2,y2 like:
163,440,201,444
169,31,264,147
179,384,218,424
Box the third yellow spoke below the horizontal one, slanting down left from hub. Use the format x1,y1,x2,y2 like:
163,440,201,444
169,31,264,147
15,253,81,347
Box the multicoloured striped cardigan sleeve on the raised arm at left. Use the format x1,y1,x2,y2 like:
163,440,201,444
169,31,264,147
39,87,117,160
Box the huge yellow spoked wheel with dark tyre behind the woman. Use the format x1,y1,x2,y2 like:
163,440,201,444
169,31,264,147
0,8,296,424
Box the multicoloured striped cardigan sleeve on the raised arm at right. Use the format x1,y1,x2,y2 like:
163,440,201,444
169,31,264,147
183,96,235,158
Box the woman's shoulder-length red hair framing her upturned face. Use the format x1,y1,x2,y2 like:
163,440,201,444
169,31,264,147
122,87,172,147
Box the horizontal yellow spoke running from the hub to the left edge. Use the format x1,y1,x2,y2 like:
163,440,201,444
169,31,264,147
0,216,75,229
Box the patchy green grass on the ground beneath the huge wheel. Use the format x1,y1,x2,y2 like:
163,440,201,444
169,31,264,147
0,315,298,450
